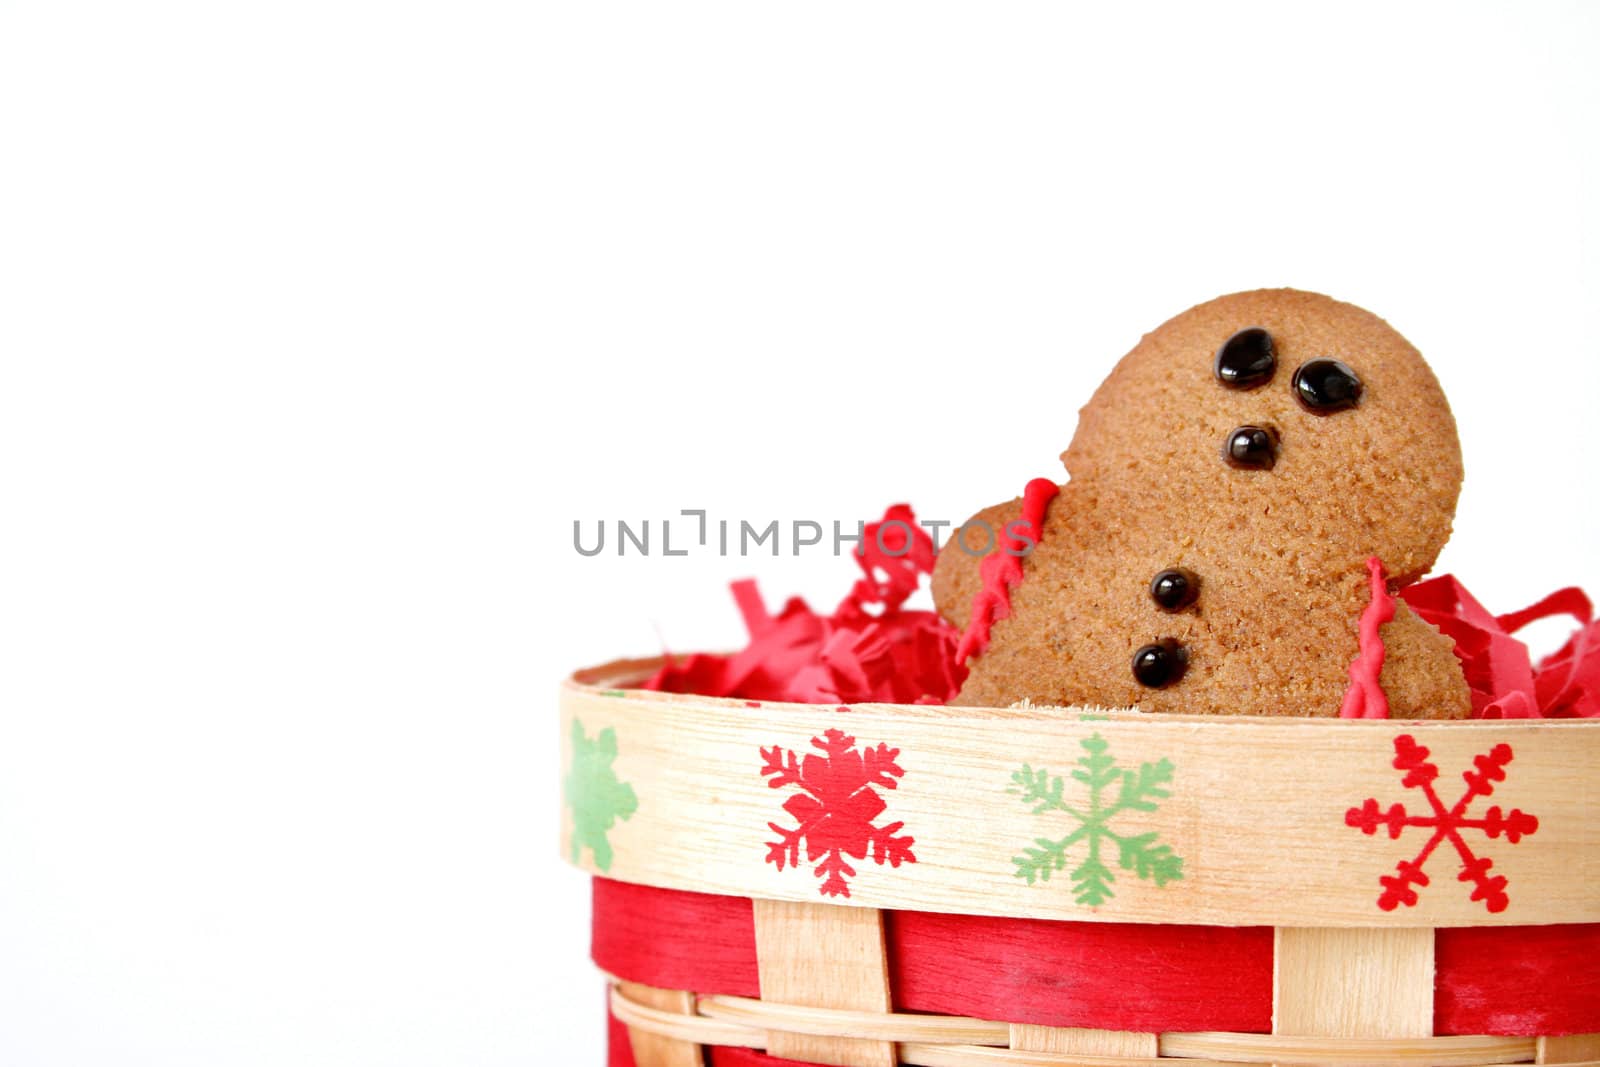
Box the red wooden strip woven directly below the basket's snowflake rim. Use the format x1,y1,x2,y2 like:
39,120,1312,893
594,878,1600,1043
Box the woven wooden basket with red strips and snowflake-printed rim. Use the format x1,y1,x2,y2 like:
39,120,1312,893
560,661,1600,1067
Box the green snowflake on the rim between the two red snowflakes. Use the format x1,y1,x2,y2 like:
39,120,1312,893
1006,734,1184,907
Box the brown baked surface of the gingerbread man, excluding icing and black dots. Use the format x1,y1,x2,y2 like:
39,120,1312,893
933,290,1470,718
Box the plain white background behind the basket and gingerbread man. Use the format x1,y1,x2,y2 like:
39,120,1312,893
0,2,1600,1065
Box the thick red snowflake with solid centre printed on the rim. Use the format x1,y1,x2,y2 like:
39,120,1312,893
762,729,917,896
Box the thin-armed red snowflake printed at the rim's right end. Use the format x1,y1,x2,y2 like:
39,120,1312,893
1344,734,1539,913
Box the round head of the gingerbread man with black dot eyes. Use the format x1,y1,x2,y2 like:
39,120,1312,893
1062,290,1461,581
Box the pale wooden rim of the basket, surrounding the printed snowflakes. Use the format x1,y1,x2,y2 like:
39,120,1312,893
560,657,1600,928
